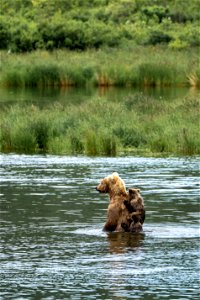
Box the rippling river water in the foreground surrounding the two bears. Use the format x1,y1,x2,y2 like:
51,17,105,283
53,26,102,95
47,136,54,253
0,155,200,300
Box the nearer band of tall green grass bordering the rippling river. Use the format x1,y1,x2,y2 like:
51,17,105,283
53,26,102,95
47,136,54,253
0,93,200,156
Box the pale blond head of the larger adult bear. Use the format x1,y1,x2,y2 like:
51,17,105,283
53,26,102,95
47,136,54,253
96,172,126,195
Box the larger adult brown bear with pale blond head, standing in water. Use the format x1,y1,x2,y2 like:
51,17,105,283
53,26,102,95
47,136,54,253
96,172,130,231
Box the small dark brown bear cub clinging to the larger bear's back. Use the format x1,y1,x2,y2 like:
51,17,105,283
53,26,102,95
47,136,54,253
122,188,145,232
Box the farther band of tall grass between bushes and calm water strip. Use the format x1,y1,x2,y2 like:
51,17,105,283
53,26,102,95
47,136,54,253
0,44,200,88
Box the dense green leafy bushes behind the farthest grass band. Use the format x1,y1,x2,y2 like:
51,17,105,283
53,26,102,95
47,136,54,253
0,0,200,52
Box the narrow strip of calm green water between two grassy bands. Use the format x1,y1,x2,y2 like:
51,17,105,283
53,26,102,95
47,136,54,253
0,87,200,107
